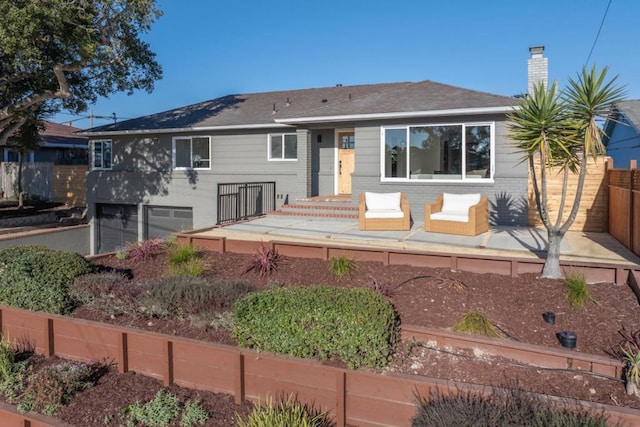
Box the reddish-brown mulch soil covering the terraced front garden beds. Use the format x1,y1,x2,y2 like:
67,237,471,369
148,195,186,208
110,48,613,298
45,253,640,426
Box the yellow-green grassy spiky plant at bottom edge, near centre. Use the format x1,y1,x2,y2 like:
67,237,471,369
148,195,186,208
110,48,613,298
236,396,335,427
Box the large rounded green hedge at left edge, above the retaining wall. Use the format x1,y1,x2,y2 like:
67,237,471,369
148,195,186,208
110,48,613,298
0,246,93,314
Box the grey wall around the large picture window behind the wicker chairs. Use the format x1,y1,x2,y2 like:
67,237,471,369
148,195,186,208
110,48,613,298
352,116,528,226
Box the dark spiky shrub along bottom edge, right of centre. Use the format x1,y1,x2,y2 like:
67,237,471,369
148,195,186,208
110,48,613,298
411,388,619,427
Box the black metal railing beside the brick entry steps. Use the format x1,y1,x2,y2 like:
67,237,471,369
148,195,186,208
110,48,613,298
217,182,276,224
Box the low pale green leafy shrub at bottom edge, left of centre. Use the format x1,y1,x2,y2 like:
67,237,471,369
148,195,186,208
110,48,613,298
123,390,209,427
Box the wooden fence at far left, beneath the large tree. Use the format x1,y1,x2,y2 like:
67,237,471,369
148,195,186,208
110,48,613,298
0,162,89,206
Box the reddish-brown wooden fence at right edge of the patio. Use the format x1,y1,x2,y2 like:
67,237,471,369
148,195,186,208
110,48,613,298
608,160,640,256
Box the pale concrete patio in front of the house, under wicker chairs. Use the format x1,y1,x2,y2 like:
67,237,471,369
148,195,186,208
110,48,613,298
196,216,640,266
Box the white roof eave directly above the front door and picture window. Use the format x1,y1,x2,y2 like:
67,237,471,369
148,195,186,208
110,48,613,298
275,105,517,124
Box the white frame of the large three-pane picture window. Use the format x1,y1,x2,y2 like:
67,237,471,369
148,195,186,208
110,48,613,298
380,122,496,184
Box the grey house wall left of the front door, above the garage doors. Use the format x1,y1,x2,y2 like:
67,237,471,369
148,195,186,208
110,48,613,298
87,128,312,251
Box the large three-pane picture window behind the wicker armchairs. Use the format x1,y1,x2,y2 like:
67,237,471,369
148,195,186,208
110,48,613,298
381,123,495,181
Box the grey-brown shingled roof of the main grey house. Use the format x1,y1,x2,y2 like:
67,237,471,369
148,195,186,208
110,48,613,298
83,80,518,134
